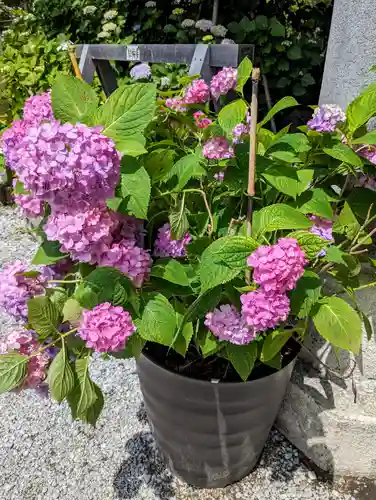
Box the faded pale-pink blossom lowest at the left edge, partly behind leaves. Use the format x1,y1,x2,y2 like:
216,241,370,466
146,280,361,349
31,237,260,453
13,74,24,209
0,328,51,390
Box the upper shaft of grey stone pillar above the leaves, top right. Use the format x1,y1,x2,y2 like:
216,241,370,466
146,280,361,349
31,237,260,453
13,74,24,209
320,0,376,109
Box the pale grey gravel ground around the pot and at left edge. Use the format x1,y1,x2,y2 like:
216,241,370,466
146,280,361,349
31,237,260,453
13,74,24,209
0,207,368,500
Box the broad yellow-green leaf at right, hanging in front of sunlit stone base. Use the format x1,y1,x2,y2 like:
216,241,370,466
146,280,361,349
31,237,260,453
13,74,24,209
313,297,362,354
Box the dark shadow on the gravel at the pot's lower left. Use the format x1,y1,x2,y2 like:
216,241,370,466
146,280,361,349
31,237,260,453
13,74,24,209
114,432,175,500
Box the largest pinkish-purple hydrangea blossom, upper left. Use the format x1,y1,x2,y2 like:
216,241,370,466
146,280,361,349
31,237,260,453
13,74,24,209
12,121,120,208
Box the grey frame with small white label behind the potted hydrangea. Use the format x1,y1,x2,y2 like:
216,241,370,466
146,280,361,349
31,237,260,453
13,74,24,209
76,44,254,96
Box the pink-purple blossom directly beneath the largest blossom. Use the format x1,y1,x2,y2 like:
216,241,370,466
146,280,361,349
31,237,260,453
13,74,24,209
44,204,118,264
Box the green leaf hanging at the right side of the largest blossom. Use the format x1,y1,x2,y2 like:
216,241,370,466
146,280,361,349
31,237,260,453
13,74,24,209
121,157,151,219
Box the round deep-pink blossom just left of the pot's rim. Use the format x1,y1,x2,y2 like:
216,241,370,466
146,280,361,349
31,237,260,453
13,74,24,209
77,302,136,352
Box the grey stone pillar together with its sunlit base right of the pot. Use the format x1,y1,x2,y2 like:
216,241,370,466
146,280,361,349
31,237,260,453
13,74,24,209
276,0,376,478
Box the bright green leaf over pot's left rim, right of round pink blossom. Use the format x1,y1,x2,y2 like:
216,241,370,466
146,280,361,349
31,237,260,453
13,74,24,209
138,293,176,346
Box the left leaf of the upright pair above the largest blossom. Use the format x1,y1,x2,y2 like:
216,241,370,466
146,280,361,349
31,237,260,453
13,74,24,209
51,74,98,125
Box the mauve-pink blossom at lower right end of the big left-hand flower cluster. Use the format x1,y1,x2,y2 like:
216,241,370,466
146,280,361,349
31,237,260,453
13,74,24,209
98,239,152,287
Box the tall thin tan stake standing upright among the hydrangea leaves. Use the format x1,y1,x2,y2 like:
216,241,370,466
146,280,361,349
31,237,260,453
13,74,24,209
246,68,260,284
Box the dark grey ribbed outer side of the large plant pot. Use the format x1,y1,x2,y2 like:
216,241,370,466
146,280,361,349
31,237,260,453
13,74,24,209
137,355,294,488
